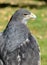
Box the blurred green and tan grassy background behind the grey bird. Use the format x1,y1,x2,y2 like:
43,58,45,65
0,0,47,65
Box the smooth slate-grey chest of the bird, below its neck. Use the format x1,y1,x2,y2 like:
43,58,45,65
6,22,29,51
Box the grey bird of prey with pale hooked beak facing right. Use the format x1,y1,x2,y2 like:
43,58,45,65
0,9,40,65
